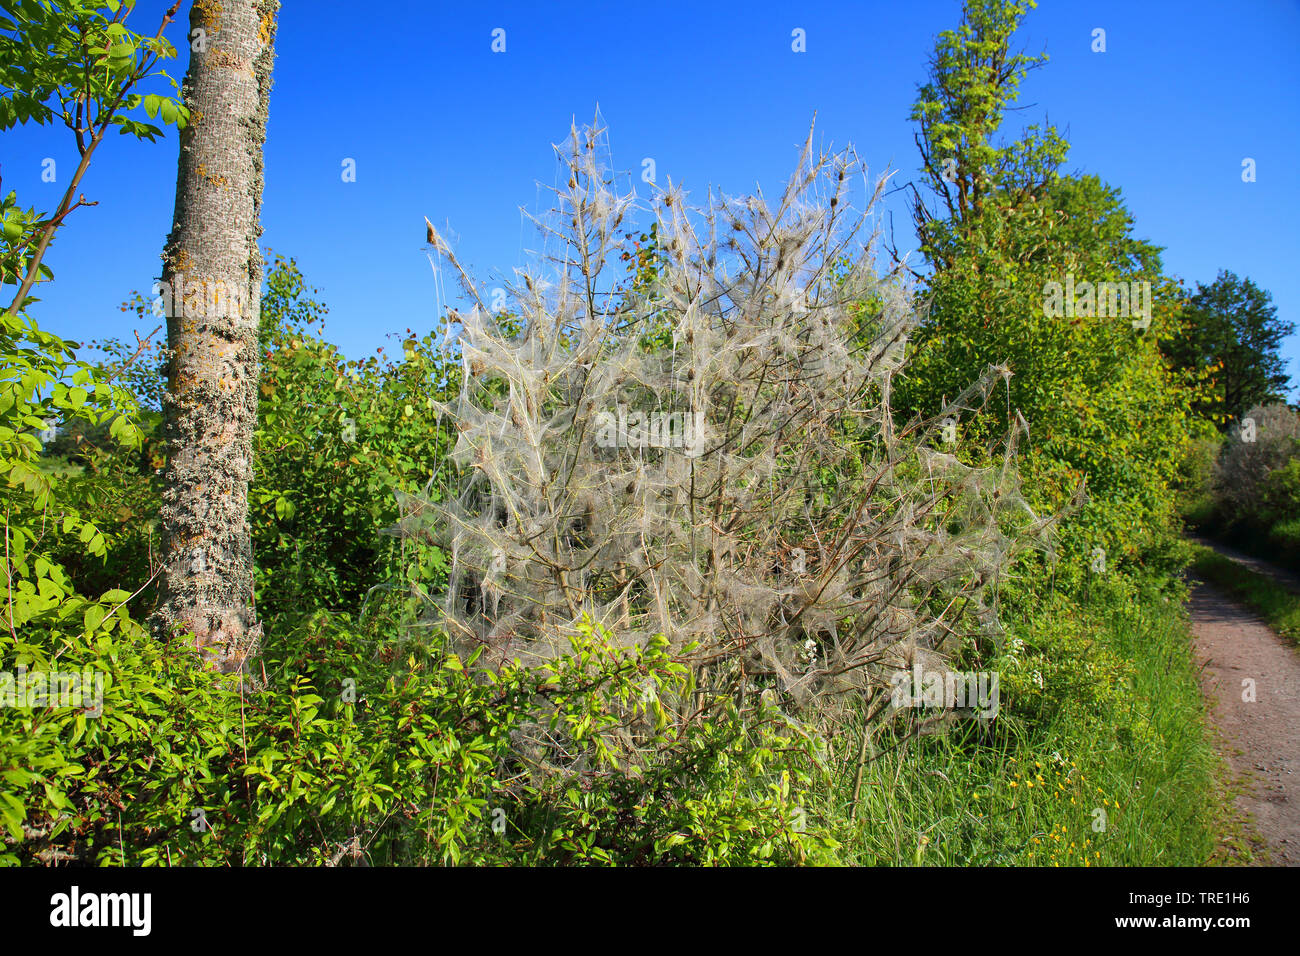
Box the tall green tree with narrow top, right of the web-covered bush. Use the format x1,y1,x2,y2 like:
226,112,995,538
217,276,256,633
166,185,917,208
896,0,1187,580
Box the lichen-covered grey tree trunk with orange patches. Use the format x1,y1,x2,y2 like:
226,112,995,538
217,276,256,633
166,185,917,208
156,0,280,672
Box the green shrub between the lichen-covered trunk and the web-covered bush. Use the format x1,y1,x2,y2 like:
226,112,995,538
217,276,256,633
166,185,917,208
250,258,460,622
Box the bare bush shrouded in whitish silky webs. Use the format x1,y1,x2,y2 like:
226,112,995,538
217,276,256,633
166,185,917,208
402,129,1045,749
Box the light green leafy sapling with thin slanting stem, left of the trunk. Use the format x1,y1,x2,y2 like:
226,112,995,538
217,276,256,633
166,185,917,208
0,0,186,637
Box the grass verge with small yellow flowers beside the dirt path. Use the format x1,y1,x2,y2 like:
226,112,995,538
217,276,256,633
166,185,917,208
827,582,1222,866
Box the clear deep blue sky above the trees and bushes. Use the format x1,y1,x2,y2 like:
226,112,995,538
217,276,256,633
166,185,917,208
0,0,1300,395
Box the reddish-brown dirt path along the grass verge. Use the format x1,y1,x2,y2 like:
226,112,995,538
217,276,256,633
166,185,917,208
1188,542,1300,866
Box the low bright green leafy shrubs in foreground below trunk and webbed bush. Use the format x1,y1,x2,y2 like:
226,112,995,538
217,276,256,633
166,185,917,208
0,598,836,865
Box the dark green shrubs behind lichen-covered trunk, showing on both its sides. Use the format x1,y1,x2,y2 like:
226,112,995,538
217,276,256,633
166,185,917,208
36,256,459,631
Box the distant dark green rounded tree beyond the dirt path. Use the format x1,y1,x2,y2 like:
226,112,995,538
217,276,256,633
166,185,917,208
1165,271,1296,428
